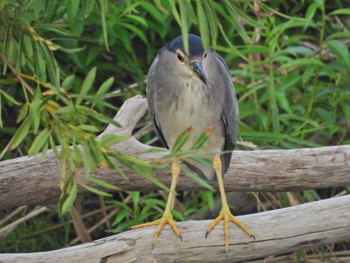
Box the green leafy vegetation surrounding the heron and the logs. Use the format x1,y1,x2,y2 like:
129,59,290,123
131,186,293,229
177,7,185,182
0,0,350,262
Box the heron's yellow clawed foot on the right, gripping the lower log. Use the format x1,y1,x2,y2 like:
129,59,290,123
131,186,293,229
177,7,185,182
205,209,255,255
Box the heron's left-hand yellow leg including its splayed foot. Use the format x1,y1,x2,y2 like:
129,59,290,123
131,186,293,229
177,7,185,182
131,160,182,248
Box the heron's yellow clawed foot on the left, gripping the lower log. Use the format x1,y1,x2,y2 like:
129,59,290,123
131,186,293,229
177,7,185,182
131,211,182,249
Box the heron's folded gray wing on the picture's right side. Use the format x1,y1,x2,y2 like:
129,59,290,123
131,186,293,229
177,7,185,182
212,51,239,175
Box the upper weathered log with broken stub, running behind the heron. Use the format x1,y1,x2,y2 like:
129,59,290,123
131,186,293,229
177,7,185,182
0,96,350,209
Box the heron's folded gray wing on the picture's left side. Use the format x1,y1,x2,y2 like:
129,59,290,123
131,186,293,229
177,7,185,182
146,50,169,149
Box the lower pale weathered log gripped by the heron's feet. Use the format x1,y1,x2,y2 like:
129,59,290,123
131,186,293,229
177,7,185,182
0,195,350,263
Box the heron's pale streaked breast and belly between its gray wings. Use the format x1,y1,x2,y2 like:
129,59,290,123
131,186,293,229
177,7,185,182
155,79,224,155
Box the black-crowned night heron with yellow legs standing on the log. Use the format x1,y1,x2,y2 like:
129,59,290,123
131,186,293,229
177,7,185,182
132,34,254,253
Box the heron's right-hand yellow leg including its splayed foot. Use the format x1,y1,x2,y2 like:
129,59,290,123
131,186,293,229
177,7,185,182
206,155,255,254
